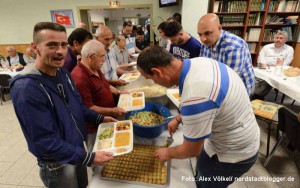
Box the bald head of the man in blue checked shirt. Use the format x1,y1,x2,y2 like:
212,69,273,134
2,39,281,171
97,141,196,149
198,13,222,46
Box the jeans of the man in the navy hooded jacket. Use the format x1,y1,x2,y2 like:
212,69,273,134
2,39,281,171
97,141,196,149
38,161,88,188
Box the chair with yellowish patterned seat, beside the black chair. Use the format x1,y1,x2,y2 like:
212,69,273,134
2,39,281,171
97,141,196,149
251,99,282,157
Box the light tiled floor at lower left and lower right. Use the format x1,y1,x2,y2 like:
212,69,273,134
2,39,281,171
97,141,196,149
0,90,300,188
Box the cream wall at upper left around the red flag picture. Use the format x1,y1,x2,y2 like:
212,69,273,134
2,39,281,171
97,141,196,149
0,0,181,44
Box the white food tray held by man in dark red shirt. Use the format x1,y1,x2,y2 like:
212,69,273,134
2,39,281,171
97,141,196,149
118,92,145,111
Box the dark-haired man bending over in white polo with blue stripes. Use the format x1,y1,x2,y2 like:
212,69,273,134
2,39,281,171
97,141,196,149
137,46,260,187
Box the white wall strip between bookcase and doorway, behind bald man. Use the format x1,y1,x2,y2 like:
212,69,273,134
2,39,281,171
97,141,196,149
181,0,209,40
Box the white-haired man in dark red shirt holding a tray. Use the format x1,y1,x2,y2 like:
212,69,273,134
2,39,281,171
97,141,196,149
71,40,127,151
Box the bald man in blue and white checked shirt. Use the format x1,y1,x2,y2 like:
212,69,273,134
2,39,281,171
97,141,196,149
198,13,255,95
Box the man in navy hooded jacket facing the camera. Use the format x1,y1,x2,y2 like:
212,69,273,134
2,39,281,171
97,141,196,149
10,22,116,188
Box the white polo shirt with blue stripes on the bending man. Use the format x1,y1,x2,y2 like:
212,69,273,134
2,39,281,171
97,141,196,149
179,57,260,163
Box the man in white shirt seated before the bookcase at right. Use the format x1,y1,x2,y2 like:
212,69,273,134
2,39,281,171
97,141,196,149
251,31,294,100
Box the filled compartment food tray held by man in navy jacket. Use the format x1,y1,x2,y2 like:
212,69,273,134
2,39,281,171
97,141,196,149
93,120,133,156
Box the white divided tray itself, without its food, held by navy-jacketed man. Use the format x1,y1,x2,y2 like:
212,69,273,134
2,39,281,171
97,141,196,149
93,120,133,156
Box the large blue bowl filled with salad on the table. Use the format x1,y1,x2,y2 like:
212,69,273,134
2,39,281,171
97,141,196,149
125,103,171,138
